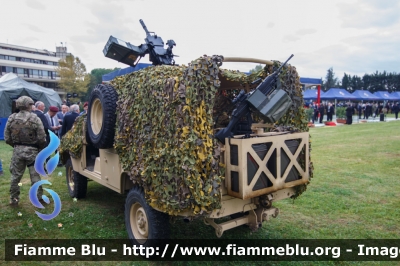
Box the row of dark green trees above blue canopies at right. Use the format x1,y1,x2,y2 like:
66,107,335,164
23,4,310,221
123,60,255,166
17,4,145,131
322,68,400,93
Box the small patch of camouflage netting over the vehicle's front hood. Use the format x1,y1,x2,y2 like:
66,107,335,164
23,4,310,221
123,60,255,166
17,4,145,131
59,114,86,158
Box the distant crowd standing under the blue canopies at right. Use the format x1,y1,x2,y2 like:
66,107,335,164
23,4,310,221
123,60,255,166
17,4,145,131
308,102,400,124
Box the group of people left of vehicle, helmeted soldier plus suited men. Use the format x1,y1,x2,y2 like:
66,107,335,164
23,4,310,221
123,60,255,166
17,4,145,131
1,96,88,207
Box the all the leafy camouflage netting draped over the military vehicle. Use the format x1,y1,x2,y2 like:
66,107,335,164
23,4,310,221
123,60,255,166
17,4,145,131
61,56,313,215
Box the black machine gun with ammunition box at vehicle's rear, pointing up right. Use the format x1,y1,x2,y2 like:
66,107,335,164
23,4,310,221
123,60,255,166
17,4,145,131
215,55,293,144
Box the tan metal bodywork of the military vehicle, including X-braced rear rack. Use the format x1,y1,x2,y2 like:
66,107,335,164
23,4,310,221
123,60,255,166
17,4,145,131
67,58,309,237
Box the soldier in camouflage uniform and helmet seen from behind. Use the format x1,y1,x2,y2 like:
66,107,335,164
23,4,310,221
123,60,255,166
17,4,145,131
4,96,46,207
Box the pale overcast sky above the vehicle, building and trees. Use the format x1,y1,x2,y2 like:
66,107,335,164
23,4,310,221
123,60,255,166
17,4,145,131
0,0,400,79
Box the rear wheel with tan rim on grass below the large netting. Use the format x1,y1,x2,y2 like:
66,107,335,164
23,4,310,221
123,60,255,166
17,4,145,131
125,186,170,246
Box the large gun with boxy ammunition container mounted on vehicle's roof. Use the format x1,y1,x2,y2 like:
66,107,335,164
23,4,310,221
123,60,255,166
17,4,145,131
103,20,176,67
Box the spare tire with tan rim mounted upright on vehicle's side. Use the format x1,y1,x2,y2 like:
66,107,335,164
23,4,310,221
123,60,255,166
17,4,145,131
87,84,118,149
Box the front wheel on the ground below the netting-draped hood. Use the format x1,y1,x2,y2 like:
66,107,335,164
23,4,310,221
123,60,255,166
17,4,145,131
65,159,88,199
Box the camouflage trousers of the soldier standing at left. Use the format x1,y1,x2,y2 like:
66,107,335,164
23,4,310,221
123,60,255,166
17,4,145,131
10,146,43,201
